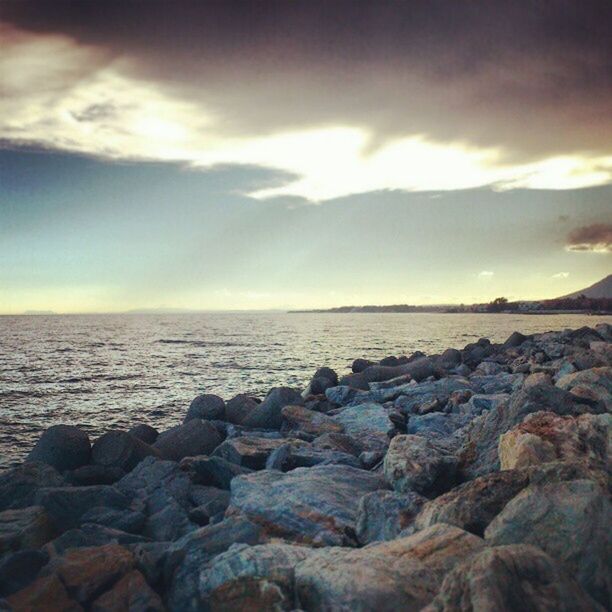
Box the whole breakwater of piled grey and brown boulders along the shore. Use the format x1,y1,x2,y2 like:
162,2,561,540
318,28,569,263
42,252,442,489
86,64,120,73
0,324,612,612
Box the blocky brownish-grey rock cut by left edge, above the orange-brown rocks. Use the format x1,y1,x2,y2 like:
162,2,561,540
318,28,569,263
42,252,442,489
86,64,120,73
0,506,53,555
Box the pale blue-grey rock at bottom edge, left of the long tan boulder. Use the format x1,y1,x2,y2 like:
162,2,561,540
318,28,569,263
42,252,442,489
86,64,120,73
200,544,312,610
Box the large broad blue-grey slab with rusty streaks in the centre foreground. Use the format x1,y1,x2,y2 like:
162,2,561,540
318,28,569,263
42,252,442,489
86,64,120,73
228,465,385,546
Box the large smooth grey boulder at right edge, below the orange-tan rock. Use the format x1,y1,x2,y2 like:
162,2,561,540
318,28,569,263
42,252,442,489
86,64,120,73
485,480,612,606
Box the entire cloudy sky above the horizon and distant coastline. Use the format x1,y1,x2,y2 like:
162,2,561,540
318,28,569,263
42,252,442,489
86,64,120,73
0,0,612,313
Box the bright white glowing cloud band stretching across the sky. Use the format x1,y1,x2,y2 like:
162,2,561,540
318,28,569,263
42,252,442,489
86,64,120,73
0,28,612,202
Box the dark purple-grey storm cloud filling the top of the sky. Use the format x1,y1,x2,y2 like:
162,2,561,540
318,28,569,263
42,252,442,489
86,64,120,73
0,0,612,160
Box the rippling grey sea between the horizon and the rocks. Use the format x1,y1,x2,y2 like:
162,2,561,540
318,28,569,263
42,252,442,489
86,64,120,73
0,313,612,466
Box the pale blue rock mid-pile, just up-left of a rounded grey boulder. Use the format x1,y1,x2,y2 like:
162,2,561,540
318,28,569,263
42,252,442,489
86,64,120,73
332,402,394,450
